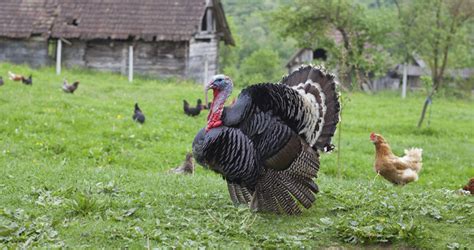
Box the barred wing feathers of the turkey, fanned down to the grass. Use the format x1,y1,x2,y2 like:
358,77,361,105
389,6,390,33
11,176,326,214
250,142,319,214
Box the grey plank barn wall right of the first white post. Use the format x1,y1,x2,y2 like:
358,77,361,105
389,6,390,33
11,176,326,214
63,40,187,77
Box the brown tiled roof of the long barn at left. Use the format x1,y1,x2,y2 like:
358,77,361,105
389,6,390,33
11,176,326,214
0,0,234,44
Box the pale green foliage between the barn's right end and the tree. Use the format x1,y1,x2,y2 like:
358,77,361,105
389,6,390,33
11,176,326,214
219,0,296,86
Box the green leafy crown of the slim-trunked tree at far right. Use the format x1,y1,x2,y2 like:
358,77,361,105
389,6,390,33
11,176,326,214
394,0,474,87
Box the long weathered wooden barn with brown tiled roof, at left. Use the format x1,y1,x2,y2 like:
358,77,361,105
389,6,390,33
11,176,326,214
0,0,234,82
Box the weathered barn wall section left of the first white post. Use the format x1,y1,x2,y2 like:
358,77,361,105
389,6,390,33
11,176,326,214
0,38,51,67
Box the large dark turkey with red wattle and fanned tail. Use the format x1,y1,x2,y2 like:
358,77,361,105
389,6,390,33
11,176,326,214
193,66,340,215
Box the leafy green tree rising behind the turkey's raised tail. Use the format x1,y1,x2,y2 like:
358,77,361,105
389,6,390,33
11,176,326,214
272,0,393,89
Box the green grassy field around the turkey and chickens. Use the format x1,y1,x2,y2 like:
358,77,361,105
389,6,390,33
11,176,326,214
0,64,474,249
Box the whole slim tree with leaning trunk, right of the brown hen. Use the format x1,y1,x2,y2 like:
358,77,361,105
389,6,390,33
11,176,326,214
396,0,474,127
